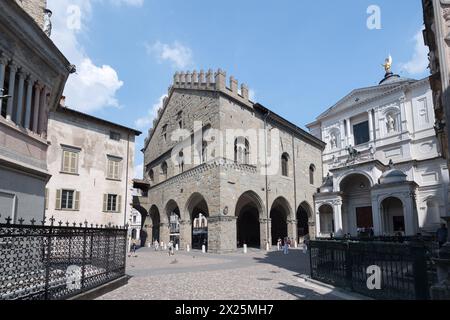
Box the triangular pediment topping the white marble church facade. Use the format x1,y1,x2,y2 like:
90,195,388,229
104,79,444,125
317,79,415,120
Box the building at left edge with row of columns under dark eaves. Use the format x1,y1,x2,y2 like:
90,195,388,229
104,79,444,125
0,0,74,222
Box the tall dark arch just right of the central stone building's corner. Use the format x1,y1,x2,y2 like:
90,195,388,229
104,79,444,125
235,192,263,249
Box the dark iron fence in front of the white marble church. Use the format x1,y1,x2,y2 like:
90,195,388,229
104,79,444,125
310,240,434,300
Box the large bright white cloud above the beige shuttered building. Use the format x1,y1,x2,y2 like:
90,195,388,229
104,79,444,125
48,0,144,112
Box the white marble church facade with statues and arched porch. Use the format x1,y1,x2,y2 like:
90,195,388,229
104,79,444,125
308,74,449,236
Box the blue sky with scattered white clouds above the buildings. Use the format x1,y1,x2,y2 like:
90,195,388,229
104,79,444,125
48,0,428,176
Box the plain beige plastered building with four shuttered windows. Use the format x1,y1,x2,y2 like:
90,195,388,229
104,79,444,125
45,105,141,226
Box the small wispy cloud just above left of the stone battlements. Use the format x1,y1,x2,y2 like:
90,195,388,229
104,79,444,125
146,41,193,68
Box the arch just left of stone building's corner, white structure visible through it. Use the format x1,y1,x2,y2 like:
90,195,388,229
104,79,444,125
187,193,209,250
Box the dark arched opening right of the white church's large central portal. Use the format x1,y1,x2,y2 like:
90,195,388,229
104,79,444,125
381,197,405,235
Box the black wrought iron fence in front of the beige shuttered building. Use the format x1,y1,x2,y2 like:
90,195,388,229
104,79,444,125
0,218,127,300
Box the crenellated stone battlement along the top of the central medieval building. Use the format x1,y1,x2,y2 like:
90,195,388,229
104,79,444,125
172,69,250,104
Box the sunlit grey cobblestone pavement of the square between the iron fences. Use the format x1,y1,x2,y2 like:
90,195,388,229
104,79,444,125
99,248,342,300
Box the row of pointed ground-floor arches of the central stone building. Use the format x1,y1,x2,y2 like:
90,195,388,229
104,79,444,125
140,191,314,250
